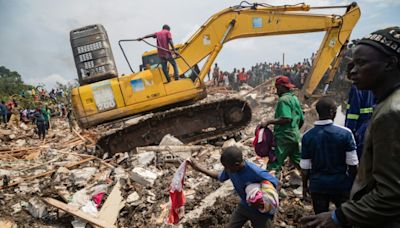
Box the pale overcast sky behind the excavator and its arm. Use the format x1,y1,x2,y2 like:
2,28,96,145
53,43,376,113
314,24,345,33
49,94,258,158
0,0,400,88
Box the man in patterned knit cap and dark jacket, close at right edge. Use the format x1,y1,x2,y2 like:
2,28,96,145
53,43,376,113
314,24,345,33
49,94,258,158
301,27,400,227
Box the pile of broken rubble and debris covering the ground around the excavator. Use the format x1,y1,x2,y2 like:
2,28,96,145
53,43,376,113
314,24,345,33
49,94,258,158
0,80,313,227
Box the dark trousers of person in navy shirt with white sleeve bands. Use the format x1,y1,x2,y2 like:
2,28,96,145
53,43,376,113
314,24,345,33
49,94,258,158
311,192,349,214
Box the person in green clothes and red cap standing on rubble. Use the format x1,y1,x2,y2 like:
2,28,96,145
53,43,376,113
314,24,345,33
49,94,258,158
261,76,304,172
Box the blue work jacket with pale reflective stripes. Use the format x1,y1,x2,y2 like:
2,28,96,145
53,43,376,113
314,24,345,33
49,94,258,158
345,85,375,158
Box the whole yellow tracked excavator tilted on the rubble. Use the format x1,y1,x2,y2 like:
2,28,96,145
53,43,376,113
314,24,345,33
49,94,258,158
70,2,360,154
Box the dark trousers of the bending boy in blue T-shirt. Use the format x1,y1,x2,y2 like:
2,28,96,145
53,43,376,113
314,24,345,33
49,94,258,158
227,204,273,228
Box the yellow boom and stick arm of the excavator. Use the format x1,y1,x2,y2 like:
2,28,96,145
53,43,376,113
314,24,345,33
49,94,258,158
177,3,360,96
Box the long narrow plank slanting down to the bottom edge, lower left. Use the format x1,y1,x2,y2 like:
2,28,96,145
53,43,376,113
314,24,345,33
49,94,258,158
42,198,116,228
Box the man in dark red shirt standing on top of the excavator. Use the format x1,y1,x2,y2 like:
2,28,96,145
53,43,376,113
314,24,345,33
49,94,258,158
138,25,179,82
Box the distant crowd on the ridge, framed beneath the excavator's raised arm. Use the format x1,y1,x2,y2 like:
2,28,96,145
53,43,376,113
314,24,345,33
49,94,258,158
208,57,314,90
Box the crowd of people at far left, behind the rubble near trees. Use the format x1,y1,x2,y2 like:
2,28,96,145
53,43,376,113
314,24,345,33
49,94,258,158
0,88,71,140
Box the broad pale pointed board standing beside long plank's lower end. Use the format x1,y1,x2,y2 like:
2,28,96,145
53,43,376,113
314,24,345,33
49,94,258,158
98,182,125,224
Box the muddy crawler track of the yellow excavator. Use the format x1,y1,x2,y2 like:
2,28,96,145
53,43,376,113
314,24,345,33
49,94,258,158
96,97,251,156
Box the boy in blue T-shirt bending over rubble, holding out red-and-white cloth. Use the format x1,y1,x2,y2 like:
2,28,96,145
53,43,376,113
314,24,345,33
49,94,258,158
189,147,278,228
